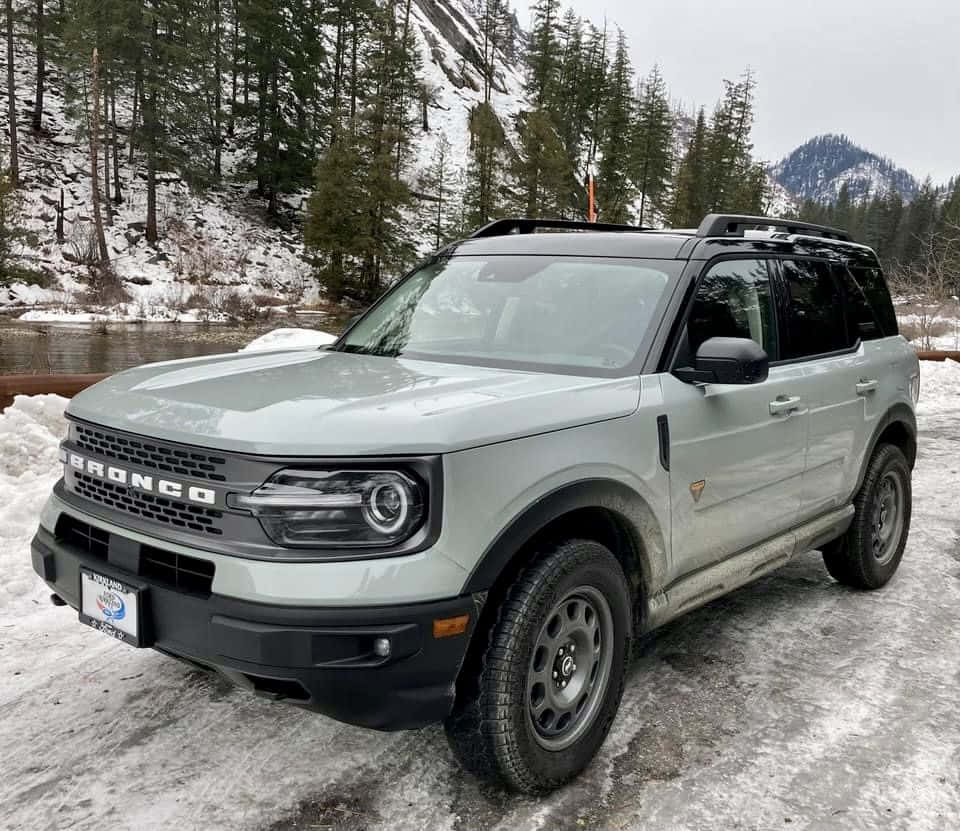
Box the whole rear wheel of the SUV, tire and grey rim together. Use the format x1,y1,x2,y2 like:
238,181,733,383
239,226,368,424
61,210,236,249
823,444,912,589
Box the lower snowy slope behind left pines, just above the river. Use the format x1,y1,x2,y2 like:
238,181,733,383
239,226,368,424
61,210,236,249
0,25,309,319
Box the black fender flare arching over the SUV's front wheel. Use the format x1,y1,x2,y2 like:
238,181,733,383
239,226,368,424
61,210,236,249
463,479,666,596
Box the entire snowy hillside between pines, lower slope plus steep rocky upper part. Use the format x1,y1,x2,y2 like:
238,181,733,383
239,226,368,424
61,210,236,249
0,0,523,320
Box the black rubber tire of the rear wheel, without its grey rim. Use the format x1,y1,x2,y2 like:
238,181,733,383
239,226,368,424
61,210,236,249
823,444,912,589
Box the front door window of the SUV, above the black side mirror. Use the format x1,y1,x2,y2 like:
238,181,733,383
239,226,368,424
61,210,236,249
687,260,777,360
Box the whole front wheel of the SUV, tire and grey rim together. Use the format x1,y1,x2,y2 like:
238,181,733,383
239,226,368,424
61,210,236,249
444,540,632,793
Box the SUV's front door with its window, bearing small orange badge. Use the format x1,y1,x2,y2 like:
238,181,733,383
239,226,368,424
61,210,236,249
661,258,809,579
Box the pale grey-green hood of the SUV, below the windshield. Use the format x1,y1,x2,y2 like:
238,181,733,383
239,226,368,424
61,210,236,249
67,349,640,456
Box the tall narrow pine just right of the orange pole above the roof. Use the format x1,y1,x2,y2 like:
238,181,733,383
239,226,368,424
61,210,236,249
597,31,634,222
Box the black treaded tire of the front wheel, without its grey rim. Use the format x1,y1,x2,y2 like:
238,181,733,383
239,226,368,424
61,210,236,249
444,539,632,794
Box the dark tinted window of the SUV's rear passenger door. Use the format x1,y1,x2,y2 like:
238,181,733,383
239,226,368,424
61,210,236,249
781,260,853,360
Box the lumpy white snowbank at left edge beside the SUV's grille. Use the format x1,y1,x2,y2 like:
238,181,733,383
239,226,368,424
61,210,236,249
0,395,67,609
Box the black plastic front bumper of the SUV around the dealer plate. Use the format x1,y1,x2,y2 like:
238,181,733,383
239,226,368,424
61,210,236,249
32,527,478,730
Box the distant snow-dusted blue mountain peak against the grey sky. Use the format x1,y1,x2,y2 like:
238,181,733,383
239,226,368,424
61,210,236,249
770,135,920,203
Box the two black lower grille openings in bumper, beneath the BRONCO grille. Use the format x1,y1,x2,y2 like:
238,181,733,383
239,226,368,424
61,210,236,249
54,514,216,595
